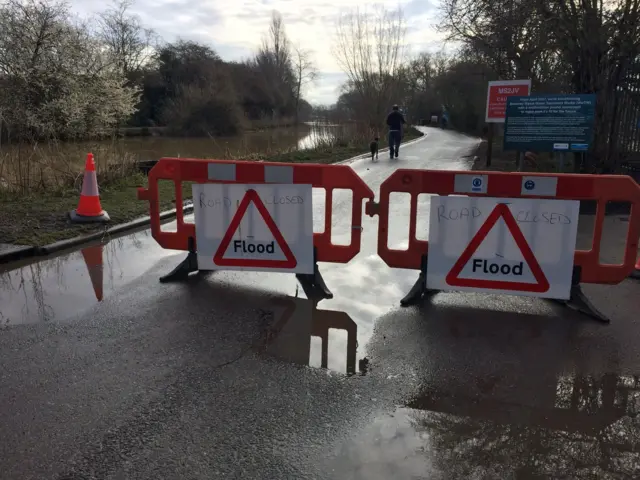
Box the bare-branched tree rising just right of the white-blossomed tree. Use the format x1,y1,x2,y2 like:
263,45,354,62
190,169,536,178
98,0,157,79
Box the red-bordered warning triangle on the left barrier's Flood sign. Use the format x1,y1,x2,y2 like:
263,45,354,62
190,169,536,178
213,189,298,268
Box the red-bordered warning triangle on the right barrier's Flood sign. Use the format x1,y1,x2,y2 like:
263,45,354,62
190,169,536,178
446,203,549,293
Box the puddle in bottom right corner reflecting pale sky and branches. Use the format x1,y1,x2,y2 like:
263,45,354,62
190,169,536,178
331,374,640,480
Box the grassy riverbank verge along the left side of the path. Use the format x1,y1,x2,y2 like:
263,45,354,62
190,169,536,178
0,128,422,251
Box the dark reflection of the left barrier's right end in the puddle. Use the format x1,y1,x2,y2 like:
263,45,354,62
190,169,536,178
266,298,358,375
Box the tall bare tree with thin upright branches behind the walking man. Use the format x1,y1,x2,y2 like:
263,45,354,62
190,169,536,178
333,8,406,129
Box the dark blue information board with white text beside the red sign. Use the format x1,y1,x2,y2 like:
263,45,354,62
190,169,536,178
503,94,596,152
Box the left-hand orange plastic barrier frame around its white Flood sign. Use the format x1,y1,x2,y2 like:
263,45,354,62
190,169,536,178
138,158,374,292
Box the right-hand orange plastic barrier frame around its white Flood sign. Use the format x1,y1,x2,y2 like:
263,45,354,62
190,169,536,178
366,169,640,318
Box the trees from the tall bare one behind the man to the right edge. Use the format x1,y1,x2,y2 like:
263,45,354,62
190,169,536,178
316,0,640,172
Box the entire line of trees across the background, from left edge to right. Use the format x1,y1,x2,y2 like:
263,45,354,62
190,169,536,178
5,0,640,171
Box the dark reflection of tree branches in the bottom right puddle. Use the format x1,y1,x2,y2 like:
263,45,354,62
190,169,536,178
407,374,640,478
